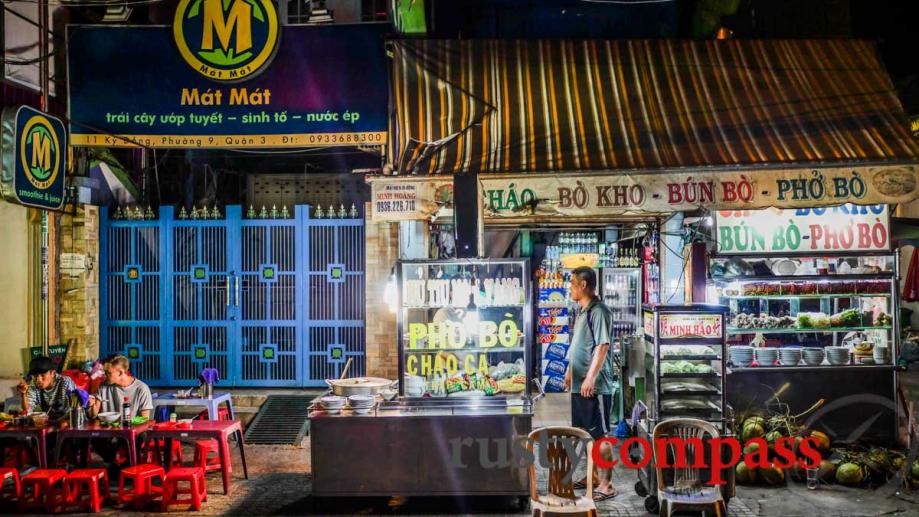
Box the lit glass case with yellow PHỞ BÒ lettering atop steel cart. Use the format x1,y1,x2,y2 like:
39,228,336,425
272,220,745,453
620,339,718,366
397,259,533,398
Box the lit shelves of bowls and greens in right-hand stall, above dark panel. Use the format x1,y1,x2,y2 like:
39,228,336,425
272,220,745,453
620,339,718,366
710,254,899,370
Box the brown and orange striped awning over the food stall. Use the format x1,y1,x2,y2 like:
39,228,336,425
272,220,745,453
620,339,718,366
390,40,919,174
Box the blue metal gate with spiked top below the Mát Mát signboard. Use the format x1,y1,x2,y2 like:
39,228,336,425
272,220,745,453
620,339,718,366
100,206,365,387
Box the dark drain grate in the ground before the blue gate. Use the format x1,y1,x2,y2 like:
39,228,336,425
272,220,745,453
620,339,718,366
246,395,313,445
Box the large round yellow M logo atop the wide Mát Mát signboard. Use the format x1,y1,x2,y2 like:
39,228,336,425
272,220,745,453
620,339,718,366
172,0,280,82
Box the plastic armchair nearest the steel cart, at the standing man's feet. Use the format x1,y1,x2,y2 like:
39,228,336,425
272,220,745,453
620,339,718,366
527,426,597,517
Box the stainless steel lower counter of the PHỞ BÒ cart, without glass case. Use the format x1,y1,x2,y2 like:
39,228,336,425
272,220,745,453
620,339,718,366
310,398,533,504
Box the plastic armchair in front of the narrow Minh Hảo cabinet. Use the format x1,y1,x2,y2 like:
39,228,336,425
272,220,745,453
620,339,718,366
652,418,727,517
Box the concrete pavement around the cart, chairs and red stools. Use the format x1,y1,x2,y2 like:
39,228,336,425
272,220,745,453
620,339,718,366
28,395,919,517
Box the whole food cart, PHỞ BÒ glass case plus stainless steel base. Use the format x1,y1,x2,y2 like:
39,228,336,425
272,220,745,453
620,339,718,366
310,259,534,505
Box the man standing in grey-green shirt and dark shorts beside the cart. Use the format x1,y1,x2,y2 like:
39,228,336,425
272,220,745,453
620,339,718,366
565,267,616,501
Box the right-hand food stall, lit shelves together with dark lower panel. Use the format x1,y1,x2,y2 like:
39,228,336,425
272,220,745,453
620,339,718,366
710,252,900,445
